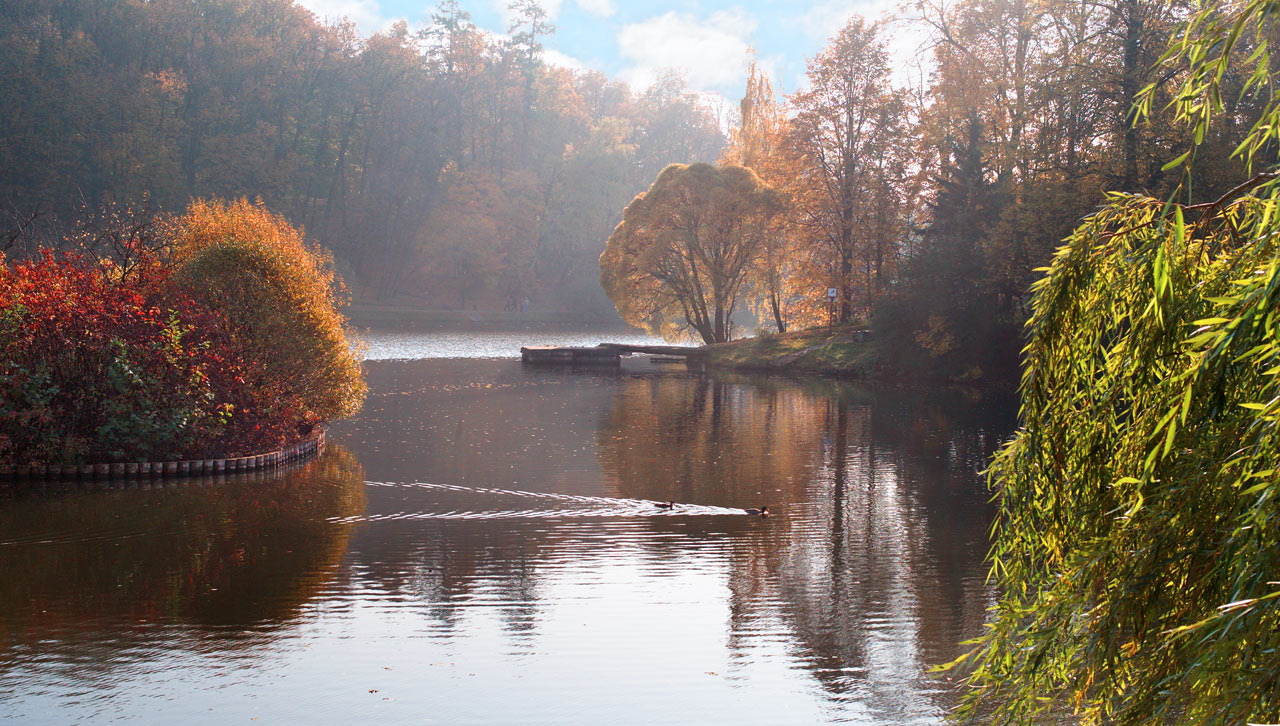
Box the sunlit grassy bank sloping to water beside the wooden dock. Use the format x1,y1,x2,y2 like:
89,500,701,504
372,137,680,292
707,325,879,378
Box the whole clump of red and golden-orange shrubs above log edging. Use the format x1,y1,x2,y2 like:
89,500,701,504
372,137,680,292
0,200,365,465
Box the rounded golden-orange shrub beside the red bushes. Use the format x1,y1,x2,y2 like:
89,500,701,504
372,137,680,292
172,200,366,442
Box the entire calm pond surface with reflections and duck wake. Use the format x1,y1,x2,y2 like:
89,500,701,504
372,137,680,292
0,339,1011,725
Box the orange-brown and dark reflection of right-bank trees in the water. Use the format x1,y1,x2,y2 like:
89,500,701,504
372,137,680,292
596,376,1012,716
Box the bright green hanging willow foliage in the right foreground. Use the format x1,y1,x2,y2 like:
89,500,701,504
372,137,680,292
957,0,1280,723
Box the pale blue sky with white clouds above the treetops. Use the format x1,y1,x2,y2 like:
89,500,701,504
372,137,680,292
298,0,919,108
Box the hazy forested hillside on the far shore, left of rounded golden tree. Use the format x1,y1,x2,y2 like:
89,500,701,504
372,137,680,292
0,0,723,314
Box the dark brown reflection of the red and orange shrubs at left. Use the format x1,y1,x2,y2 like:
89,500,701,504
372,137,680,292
0,446,365,654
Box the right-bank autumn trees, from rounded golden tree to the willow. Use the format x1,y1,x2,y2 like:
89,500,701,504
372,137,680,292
602,0,1261,379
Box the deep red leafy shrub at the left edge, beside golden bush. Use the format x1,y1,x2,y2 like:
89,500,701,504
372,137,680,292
0,251,228,464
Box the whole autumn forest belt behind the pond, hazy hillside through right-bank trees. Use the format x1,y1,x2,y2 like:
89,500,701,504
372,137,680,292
0,0,1260,379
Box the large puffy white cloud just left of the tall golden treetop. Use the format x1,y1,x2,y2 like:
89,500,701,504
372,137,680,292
618,9,756,95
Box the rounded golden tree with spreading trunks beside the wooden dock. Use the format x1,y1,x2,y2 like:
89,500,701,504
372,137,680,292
600,164,782,343
